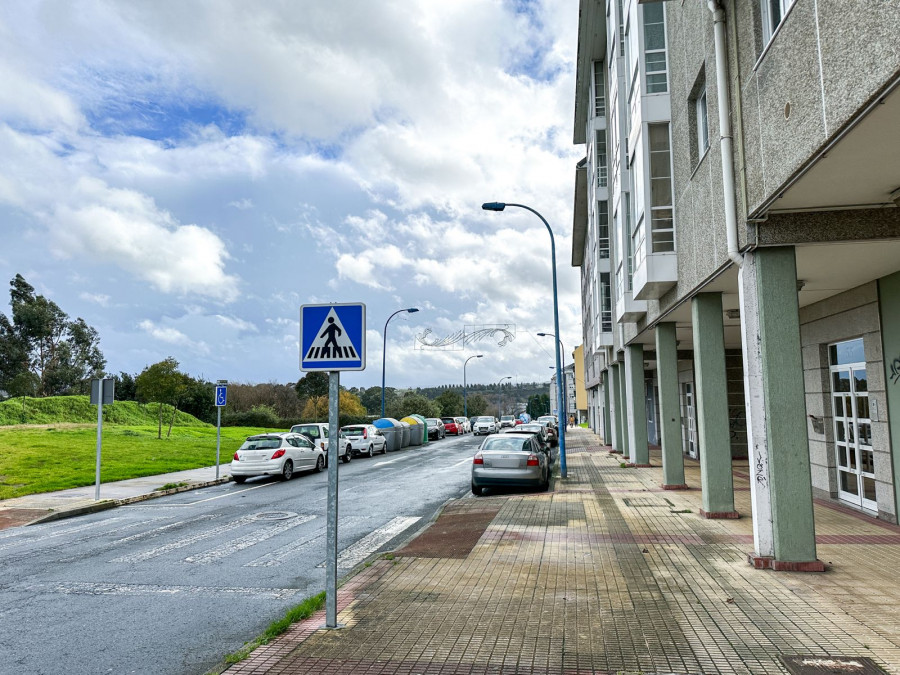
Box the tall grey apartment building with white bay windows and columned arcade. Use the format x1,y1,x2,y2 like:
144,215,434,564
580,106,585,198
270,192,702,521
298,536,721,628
572,0,900,569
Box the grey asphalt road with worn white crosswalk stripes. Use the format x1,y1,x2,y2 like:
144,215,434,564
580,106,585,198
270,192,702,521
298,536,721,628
0,435,482,675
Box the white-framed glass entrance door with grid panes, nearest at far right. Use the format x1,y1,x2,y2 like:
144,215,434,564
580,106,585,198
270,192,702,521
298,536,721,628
828,338,878,511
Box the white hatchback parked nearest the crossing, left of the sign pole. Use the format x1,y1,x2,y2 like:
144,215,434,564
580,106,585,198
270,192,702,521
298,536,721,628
231,433,325,483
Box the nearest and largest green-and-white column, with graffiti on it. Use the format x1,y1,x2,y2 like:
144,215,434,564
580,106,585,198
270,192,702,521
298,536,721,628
742,246,824,571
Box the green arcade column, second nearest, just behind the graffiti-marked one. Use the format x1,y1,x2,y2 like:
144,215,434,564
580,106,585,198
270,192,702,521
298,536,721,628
691,293,740,518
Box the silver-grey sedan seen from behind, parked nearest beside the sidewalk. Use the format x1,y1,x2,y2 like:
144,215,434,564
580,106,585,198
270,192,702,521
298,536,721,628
472,433,550,495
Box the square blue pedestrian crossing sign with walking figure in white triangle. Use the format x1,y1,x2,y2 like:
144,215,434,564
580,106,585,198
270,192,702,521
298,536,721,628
300,303,366,371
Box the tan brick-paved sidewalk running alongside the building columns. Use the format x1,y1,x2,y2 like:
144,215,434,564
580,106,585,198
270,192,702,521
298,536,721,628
227,429,900,675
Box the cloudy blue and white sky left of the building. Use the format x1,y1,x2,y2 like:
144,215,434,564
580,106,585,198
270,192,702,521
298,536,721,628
0,0,583,387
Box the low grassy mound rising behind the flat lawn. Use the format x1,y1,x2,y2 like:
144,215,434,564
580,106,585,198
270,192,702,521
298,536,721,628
0,396,211,427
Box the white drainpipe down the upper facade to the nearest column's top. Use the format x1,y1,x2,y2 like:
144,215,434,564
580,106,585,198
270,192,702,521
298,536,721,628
707,0,744,267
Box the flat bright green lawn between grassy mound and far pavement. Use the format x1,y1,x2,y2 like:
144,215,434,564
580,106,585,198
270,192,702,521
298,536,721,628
0,424,271,499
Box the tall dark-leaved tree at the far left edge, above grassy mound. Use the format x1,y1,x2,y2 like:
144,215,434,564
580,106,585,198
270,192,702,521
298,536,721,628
0,274,106,396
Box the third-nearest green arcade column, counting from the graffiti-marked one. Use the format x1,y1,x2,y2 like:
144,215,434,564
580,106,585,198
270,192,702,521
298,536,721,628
656,323,687,490
